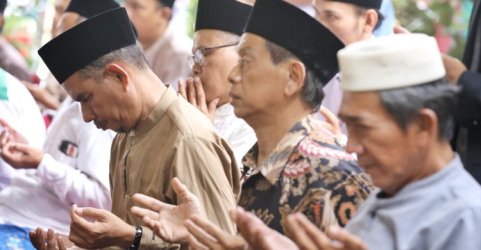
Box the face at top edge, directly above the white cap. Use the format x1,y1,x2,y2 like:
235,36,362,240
312,0,366,45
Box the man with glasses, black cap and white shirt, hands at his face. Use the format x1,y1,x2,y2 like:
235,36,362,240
179,0,257,171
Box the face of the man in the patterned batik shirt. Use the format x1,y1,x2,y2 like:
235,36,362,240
229,33,289,120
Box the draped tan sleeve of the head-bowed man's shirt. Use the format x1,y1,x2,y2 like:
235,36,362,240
166,136,240,235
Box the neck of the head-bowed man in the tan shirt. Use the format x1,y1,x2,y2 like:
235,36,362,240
139,70,167,121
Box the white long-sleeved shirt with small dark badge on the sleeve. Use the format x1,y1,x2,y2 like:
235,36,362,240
0,98,114,234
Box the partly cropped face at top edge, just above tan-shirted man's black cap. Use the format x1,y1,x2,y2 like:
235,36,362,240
125,0,165,43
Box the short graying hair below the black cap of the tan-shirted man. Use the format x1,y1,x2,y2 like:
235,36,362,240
78,45,150,83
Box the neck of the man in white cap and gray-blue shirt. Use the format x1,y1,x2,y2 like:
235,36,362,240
384,141,454,197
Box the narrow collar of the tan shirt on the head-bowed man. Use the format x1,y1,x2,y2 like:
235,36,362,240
130,86,177,136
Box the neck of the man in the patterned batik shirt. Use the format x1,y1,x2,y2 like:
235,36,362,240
245,99,312,165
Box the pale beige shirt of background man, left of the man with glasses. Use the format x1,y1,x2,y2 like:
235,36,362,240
144,26,192,90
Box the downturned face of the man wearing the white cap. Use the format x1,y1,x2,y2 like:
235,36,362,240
339,91,424,193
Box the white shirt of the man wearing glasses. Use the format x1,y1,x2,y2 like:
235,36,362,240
214,103,257,171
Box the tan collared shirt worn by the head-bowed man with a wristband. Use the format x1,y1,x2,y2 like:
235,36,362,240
110,87,240,250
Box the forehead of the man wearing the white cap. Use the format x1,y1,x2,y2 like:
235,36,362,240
339,91,392,121
